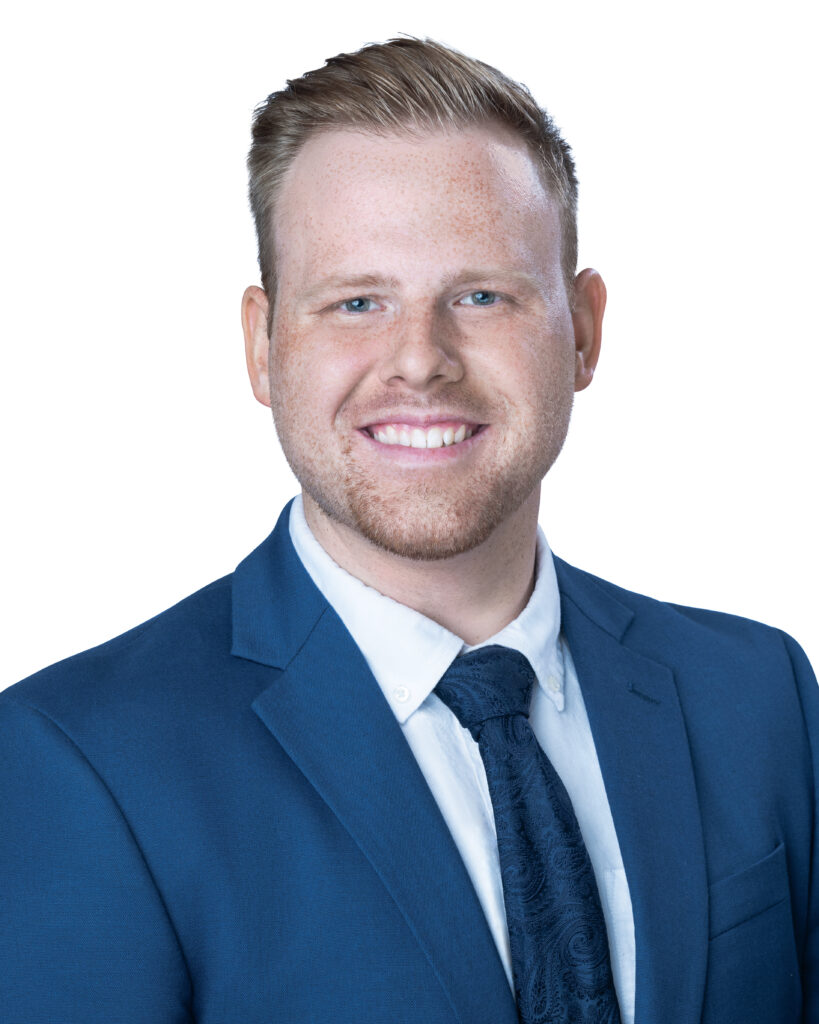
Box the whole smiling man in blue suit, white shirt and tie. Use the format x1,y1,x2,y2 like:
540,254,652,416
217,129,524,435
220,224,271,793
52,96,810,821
0,39,819,1024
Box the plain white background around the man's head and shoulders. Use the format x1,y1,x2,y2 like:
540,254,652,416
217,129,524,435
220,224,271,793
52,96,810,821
0,0,819,686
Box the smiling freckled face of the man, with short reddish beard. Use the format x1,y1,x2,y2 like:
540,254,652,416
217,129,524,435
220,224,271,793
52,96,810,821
249,128,596,559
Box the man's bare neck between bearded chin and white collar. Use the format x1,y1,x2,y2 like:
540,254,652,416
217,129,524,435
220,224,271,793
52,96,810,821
303,489,540,644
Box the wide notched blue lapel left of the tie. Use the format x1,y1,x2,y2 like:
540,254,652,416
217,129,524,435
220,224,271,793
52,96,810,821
232,506,517,1024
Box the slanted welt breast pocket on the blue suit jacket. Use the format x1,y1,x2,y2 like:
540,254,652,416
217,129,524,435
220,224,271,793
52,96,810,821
708,843,789,939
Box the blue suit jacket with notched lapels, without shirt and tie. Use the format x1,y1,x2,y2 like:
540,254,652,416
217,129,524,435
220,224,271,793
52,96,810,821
0,510,819,1024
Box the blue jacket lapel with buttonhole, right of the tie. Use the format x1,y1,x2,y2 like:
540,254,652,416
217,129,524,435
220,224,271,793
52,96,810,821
555,559,708,1024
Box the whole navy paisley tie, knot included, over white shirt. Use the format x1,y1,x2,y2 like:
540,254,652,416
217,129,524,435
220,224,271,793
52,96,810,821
434,645,620,1024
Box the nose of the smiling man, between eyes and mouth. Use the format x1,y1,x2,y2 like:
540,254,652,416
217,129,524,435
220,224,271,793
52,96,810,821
379,313,464,391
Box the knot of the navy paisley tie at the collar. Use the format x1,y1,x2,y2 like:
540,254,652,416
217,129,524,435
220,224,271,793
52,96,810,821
433,644,534,739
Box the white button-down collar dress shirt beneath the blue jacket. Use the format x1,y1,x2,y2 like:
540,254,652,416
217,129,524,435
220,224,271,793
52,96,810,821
290,496,635,1024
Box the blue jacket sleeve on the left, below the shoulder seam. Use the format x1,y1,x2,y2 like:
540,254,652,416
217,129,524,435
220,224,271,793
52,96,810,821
0,693,192,1024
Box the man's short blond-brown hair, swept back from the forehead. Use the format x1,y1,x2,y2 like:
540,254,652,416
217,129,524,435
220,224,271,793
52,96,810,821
248,36,577,311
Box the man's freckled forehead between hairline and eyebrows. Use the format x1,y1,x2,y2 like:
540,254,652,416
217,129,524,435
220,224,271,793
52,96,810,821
273,126,559,284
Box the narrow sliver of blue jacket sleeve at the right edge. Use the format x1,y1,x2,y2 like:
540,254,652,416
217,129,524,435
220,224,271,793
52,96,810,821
783,634,819,1024
